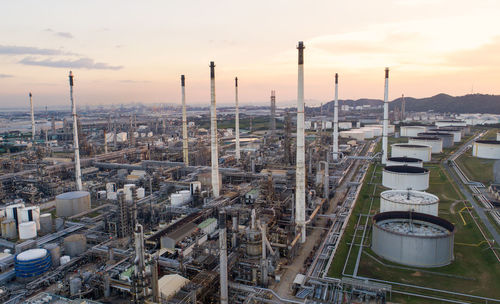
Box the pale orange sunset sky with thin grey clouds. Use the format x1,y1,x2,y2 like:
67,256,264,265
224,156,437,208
0,0,500,107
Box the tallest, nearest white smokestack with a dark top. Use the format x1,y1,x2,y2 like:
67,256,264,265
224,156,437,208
295,41,306,243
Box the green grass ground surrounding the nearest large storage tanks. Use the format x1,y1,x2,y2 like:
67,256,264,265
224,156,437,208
329,160,500,303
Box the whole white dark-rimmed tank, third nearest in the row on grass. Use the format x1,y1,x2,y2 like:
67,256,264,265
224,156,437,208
382,166,429,191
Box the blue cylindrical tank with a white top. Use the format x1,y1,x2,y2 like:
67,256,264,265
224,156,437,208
14,248,52,280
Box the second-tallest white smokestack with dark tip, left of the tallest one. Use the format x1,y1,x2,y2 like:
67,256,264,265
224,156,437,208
210,61,219,198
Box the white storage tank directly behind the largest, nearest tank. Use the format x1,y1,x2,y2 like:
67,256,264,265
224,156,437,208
380,190,439,216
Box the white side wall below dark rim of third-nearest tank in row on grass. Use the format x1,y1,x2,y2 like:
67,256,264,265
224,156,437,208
382,169,429,191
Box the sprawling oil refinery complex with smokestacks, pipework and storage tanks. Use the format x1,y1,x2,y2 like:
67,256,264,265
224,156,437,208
0,42,500,304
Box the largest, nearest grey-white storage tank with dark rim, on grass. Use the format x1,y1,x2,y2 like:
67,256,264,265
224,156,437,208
372,211,455,267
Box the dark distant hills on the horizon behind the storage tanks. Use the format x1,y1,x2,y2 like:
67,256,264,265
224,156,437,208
318,94,500,114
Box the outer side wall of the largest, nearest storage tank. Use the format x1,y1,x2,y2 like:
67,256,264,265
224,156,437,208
372,220,453,267
